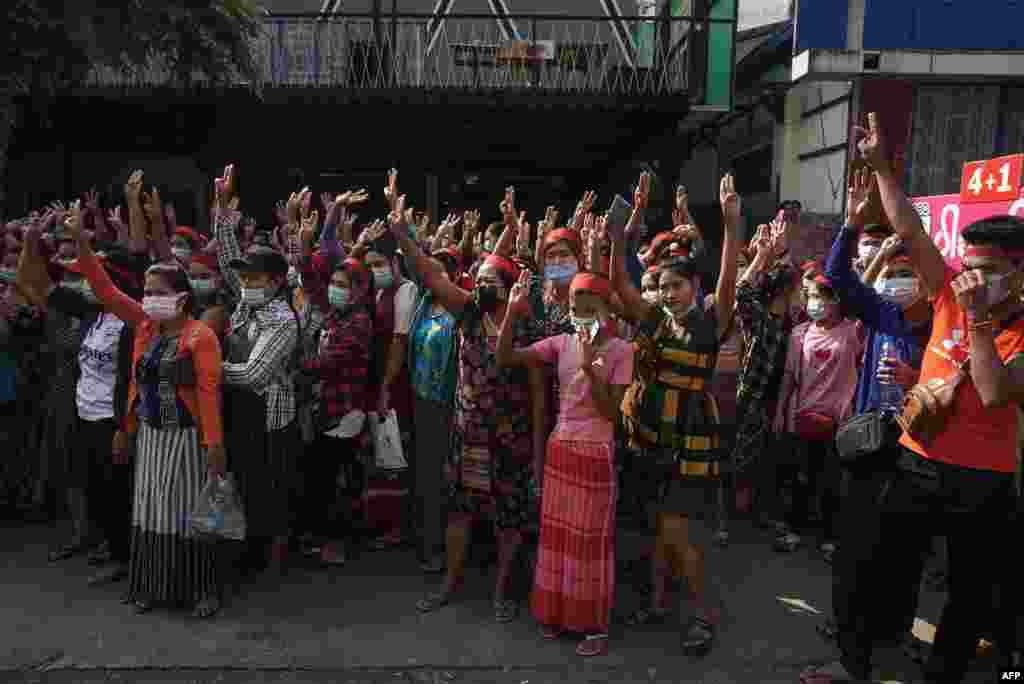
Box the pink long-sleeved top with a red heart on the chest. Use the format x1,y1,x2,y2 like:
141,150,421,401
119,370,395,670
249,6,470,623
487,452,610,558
780,318,863,432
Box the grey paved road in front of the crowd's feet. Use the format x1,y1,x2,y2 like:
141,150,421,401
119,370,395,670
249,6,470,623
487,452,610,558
0,518,1007,684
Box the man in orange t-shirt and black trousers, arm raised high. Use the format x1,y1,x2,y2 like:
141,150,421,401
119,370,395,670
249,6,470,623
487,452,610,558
802,114,1024,684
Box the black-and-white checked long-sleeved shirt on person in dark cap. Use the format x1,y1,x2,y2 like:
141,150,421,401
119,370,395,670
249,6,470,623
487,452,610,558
214,211,299,430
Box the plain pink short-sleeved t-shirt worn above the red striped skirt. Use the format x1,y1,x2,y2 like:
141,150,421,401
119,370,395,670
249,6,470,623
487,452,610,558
529,335,633,443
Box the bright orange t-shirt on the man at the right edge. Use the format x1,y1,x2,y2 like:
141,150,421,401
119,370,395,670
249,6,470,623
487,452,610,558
900,270,1024,473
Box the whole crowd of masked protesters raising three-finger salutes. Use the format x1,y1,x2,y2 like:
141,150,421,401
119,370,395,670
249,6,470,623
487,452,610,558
0,116,1024,684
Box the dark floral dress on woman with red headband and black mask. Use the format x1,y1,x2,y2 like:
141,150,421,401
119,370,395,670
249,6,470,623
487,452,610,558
449,301,538,529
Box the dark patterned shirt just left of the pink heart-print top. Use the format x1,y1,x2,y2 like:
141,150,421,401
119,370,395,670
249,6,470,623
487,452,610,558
736,273,794,402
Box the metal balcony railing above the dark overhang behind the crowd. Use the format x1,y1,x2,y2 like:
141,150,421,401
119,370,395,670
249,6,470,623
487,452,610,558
81,13,714,96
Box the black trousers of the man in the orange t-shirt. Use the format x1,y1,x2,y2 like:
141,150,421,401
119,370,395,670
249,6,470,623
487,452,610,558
840,450,1016,684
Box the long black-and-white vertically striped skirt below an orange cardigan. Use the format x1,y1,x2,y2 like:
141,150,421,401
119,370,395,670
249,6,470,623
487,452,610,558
128,423,219,606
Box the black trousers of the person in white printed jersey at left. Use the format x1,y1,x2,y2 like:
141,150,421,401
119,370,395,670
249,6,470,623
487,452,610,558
75,418,134,563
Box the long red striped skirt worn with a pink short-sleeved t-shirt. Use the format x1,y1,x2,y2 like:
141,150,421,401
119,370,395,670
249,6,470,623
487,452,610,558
529,437,616,632
